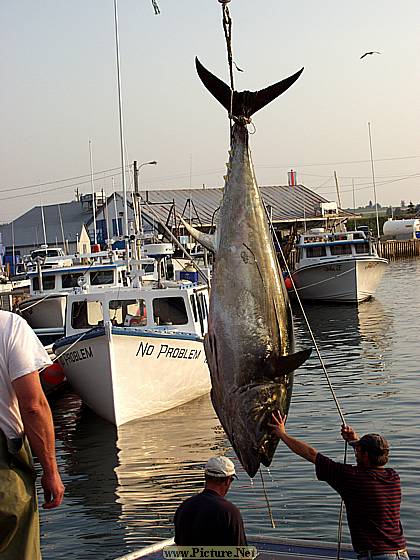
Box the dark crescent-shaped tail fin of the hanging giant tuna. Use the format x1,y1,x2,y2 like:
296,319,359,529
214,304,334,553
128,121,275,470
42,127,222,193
195,57,303,118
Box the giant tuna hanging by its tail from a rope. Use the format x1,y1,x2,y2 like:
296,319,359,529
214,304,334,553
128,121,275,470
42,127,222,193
184,59,310,477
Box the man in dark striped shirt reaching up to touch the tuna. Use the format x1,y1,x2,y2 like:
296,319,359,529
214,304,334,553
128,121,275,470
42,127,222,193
271,413,408,560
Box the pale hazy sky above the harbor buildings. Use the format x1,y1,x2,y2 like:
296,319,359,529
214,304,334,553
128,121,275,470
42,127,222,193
0,0,420,222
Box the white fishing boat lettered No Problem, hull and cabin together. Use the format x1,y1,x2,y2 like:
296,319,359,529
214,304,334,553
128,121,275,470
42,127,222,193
53,281,210,426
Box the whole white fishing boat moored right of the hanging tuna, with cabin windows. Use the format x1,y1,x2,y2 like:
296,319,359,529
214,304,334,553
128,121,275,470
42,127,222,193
292,228,388,303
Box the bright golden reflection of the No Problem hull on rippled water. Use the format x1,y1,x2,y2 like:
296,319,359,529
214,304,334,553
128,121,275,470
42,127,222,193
116,396,226,545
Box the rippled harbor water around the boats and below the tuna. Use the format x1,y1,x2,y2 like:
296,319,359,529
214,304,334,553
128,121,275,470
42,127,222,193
40,259,420,560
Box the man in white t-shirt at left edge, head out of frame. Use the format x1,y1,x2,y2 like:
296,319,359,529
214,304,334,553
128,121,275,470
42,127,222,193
0,311,64,560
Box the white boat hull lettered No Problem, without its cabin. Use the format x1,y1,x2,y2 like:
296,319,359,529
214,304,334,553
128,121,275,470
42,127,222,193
54,325,210,426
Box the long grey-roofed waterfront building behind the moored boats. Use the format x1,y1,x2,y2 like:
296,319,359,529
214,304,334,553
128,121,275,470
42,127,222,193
0,179,353,266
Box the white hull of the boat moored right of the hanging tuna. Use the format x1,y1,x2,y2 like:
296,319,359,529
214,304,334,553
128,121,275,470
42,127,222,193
293,257,388,303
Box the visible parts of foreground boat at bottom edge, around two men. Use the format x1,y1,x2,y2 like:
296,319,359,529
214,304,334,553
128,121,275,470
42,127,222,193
116,537,420,560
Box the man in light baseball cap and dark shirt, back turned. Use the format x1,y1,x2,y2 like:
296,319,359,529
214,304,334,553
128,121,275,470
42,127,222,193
174,456,247,546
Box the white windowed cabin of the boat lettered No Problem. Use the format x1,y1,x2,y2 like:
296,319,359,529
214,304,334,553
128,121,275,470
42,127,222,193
66,283,209,336
